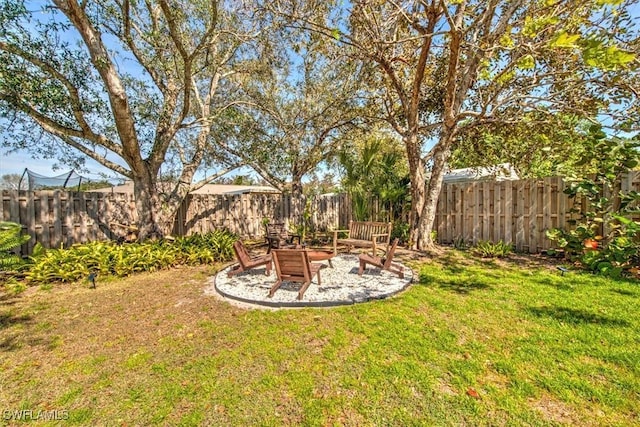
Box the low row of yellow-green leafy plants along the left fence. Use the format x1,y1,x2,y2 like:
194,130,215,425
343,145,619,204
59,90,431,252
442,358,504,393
26,230,237,283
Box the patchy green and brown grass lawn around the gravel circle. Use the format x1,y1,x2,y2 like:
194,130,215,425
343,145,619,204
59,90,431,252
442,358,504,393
0,251,640,426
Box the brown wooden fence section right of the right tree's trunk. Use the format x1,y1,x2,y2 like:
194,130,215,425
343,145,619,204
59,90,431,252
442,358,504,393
434,172,640,253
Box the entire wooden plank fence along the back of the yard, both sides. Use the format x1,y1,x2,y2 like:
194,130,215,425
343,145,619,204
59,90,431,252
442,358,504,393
0,172,640,255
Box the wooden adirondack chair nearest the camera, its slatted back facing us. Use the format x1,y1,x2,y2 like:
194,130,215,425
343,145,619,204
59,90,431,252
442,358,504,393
269,249,322,300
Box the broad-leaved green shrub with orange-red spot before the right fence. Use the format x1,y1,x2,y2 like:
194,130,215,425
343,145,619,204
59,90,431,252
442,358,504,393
547,133,640,277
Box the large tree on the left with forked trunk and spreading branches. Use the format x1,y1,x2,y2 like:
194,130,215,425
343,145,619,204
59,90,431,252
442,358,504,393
0,0,261,236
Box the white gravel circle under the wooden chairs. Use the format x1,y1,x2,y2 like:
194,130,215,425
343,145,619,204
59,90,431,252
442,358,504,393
205,255,413,308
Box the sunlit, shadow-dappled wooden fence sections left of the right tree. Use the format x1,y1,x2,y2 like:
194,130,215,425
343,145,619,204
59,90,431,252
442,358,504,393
0,190,351,255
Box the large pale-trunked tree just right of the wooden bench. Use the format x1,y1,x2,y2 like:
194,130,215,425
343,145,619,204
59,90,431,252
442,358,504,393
274,0,638,249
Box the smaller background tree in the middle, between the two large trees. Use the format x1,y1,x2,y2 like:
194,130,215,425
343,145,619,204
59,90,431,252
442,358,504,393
214,15,363,215
